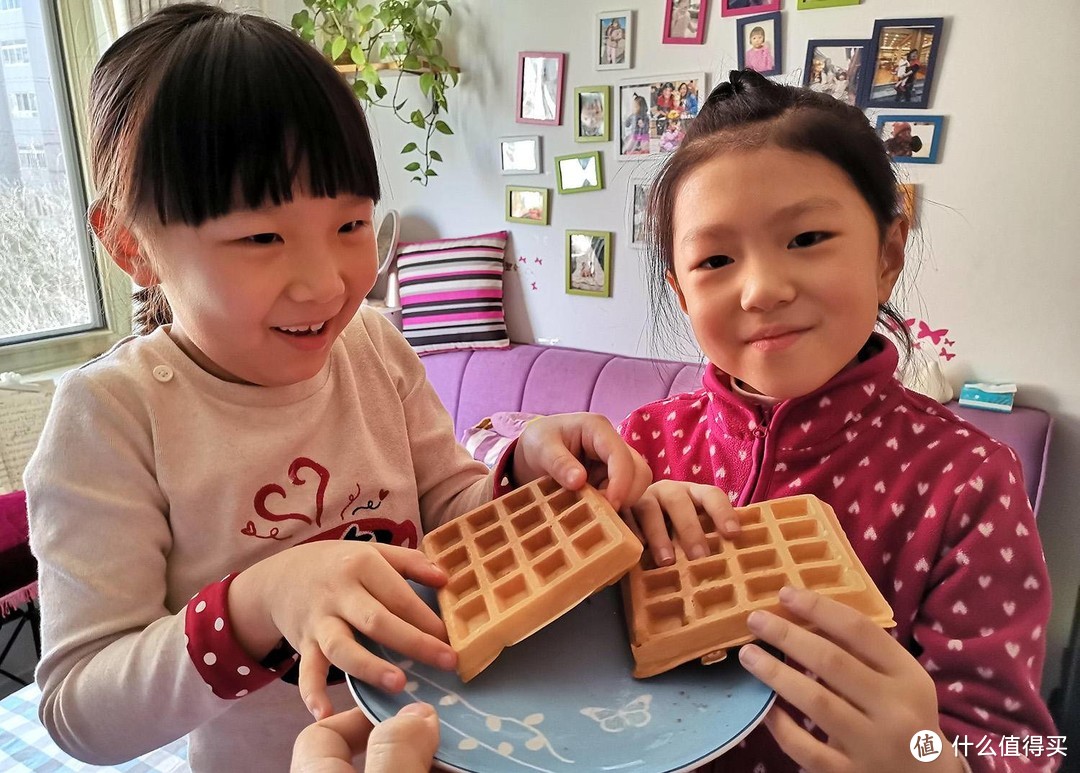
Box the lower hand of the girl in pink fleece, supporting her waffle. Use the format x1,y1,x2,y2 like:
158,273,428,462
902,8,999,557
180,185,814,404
739,587,964,773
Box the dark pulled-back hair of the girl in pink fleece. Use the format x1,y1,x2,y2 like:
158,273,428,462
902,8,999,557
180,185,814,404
645,70,912,355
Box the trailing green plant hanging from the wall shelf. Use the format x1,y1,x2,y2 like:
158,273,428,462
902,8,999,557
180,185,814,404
293,0,459,186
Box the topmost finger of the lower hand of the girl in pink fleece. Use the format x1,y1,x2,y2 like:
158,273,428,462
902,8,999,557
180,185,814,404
780,587,902,674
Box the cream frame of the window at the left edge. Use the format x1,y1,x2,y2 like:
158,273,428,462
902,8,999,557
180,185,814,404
0,0,132,374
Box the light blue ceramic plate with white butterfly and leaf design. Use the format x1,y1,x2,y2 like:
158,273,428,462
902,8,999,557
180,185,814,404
349,586,774,773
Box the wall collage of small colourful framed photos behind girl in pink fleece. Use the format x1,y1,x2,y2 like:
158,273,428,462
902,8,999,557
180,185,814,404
498,0,945,297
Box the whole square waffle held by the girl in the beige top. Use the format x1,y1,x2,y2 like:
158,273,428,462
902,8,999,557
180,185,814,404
420,478,642,681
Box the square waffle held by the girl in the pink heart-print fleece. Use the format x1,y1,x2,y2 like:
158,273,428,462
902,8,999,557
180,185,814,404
622,494,895,677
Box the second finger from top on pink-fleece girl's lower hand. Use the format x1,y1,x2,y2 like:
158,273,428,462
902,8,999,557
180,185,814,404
746,611,883,711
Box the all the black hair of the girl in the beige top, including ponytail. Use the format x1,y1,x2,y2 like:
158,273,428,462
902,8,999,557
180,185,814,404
90,3,380,331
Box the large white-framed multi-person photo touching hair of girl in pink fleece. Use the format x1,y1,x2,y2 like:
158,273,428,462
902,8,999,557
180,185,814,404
612,72,708,161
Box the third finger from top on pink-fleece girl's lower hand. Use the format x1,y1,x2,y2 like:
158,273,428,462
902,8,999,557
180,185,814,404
739,645,880,740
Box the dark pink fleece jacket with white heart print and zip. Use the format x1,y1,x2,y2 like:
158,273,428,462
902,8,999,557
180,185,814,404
620,336,1062,773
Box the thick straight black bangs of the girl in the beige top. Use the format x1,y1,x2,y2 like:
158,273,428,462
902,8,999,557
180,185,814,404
131,15,379,226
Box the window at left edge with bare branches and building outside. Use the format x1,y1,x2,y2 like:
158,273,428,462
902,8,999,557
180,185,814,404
0,0,109,372
